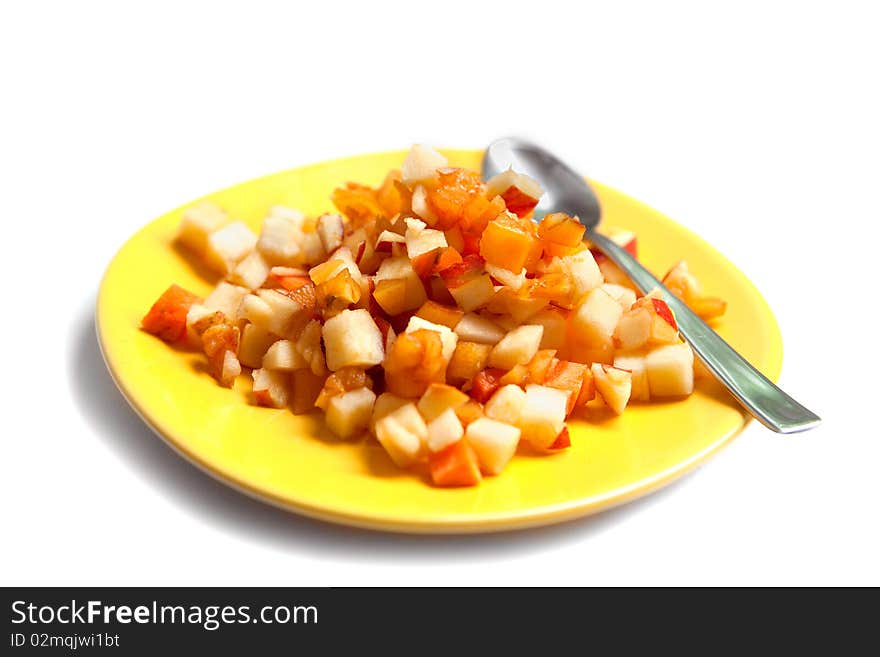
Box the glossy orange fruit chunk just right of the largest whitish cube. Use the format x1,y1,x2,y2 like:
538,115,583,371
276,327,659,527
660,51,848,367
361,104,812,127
384,329,446,397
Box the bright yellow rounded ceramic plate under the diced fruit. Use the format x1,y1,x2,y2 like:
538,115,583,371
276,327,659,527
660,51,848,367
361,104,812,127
97,151,782,533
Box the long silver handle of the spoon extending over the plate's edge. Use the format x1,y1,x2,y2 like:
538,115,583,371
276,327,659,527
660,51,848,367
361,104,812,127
585,231,821,433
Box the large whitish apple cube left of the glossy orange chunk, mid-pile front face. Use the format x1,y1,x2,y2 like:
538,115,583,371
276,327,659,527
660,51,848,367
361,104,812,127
323,308,385,372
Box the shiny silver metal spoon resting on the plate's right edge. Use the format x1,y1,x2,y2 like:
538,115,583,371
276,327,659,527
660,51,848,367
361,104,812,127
483,137,821,433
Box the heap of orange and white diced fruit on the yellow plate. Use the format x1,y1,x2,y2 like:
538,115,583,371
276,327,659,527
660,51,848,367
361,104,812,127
142,146,725,486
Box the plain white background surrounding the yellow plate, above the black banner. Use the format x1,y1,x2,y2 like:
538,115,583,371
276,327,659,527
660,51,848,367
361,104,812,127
0,0,880,585
